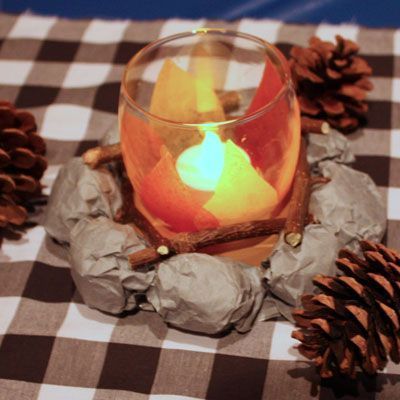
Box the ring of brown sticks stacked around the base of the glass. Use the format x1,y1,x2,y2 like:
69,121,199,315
83,101,329,268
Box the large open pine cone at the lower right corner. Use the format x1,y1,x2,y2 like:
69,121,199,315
292,241,400,378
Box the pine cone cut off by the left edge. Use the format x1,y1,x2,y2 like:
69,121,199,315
0,101,47,238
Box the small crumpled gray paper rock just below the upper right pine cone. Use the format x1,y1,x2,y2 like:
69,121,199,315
307,129,355,166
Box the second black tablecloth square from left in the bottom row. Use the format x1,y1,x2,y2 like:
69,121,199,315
98,343,161,394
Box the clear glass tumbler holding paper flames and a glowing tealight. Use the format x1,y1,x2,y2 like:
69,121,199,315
119,29,300,235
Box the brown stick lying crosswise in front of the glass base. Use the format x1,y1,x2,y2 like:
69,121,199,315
128,218,286,269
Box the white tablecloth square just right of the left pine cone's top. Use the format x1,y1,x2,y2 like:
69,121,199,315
40,104,91,141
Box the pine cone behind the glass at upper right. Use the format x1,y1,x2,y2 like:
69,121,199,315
289,35,373,133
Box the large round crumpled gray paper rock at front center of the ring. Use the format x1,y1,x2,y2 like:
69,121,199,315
147,253,265,334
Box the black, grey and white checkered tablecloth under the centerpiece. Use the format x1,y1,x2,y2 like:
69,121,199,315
0,14,400,400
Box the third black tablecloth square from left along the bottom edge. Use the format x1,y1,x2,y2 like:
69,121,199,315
206,354,268,400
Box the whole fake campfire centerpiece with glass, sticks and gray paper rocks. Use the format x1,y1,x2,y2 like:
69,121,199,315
45,29,386,344
